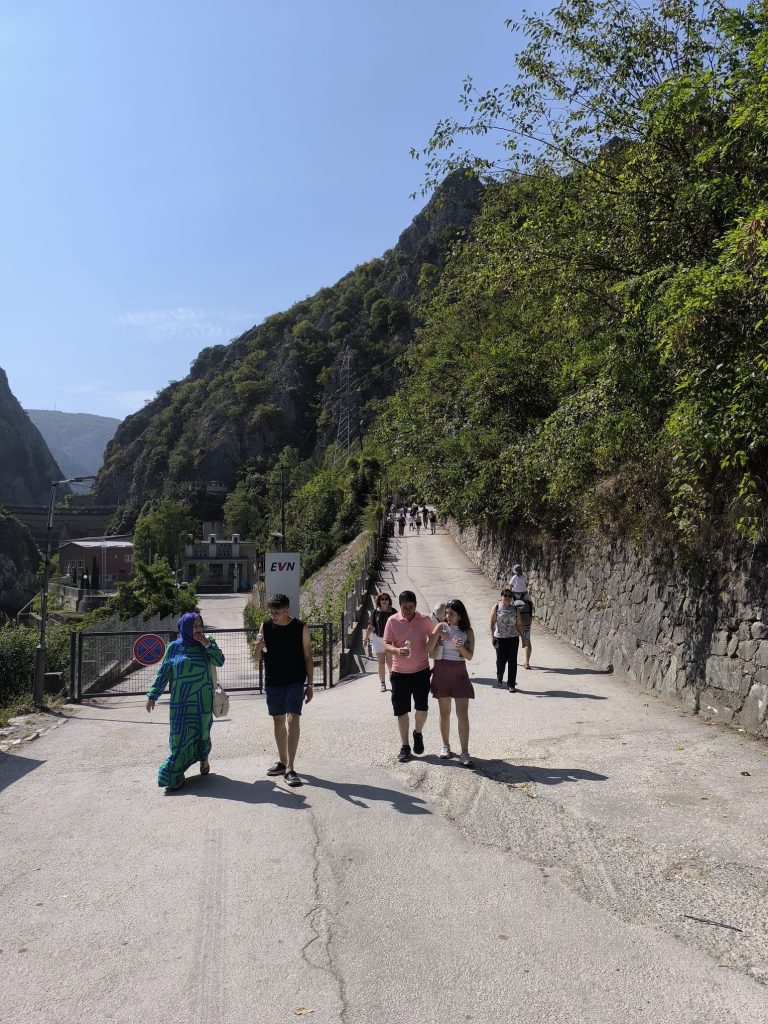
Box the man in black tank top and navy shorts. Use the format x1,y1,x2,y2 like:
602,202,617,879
254,594,314,785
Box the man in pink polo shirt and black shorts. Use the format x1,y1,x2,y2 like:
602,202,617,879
384,590,438,761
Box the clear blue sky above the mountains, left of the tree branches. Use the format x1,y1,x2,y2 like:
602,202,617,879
0,0,521,418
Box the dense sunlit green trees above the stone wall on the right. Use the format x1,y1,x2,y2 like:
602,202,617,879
370,0,768,545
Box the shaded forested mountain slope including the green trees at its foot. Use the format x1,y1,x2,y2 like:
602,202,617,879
97,174,482,560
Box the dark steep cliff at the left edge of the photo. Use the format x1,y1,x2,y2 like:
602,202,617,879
0,370,69,505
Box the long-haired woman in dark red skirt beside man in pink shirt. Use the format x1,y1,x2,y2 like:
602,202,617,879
432,599,475,768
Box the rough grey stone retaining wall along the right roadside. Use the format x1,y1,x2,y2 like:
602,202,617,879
452,525,768,736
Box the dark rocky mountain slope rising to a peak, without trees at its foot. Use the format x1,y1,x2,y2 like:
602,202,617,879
96,174,482,528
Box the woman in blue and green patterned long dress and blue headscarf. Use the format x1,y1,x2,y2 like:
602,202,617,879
146,611,224,790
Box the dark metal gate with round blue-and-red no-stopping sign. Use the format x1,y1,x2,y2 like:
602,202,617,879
70,623,334,700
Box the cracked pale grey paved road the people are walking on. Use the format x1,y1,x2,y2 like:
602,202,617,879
0,534,768,1024
